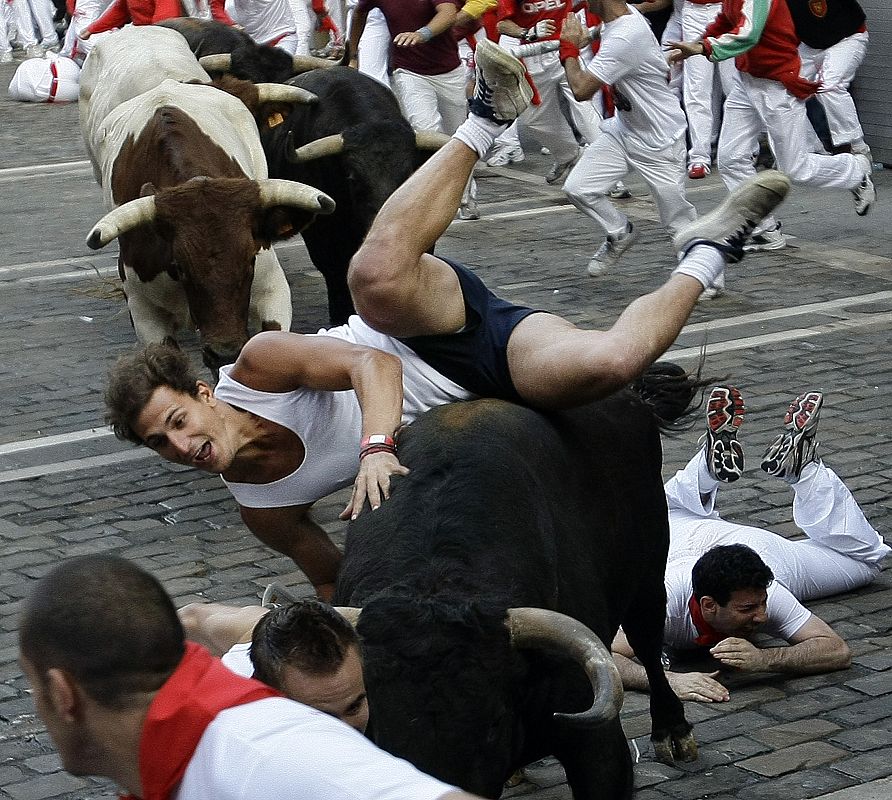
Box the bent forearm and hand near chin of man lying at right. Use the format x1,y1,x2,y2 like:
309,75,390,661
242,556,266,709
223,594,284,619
710,614,852,675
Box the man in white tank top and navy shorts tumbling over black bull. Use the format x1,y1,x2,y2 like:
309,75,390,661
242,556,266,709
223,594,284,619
106,28,790,599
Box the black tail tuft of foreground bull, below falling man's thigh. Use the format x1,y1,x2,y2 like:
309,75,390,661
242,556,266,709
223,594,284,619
632,351,724,433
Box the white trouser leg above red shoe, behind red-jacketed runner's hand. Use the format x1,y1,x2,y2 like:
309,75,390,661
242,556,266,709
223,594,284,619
681,2,722,165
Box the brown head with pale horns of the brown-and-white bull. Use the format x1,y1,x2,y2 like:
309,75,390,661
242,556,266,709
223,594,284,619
87,177,334,370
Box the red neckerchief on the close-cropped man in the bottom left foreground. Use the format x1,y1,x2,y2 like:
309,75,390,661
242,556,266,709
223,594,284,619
121,642,282,800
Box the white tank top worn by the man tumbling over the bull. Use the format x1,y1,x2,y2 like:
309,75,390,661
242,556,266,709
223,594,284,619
214,316,475,508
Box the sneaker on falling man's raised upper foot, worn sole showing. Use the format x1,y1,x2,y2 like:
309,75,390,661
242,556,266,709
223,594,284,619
468,39,533,123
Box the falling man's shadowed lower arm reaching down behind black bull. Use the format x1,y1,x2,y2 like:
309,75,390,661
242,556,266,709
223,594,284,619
239,505,342,600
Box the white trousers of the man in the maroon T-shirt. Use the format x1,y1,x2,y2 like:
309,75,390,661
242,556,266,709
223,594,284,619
391,64,468,134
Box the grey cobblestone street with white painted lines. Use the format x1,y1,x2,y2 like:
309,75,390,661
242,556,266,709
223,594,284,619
0,51,892,800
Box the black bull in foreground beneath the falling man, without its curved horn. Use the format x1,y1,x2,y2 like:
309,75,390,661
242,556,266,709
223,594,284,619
335,391,696,800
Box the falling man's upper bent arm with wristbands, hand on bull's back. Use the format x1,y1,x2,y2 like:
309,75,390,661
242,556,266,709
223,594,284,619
231,331,408,520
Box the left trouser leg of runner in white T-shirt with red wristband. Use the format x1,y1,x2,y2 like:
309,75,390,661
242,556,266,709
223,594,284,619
564,133,629,234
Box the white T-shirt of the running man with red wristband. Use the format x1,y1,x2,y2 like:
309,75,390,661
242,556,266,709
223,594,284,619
586,9,687,150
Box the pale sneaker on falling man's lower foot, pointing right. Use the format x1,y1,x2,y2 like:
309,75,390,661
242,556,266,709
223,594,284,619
672,169,790,264
